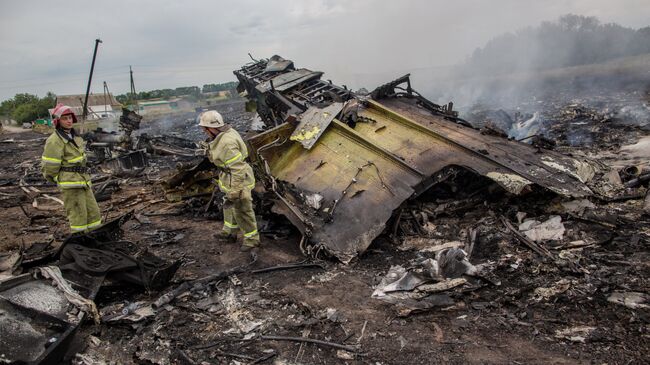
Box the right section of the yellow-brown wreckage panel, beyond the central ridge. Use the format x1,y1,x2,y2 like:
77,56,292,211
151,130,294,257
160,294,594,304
355,99,594,197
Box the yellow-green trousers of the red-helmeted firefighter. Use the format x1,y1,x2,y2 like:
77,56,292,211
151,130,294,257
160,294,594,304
61,187,102,233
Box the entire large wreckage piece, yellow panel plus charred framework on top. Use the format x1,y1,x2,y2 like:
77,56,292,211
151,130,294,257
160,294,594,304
235,55,594,262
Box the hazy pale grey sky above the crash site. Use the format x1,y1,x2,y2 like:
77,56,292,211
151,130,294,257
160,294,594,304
0,0,650,100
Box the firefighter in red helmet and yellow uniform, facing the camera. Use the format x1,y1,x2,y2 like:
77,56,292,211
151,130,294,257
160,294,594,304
41,104,102,233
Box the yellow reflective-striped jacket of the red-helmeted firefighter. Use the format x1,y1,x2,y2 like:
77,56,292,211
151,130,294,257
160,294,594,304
41,129,91,189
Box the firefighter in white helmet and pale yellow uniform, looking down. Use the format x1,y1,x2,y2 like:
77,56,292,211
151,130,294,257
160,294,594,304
199,110,260,252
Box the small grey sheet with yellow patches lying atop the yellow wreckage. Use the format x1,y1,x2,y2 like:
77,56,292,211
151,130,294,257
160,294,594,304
289,103,343,149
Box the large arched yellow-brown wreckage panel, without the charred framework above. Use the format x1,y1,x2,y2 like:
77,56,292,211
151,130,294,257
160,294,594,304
250,102,588,262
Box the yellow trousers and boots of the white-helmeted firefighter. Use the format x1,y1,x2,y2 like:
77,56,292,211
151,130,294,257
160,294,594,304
223,189,260,246
